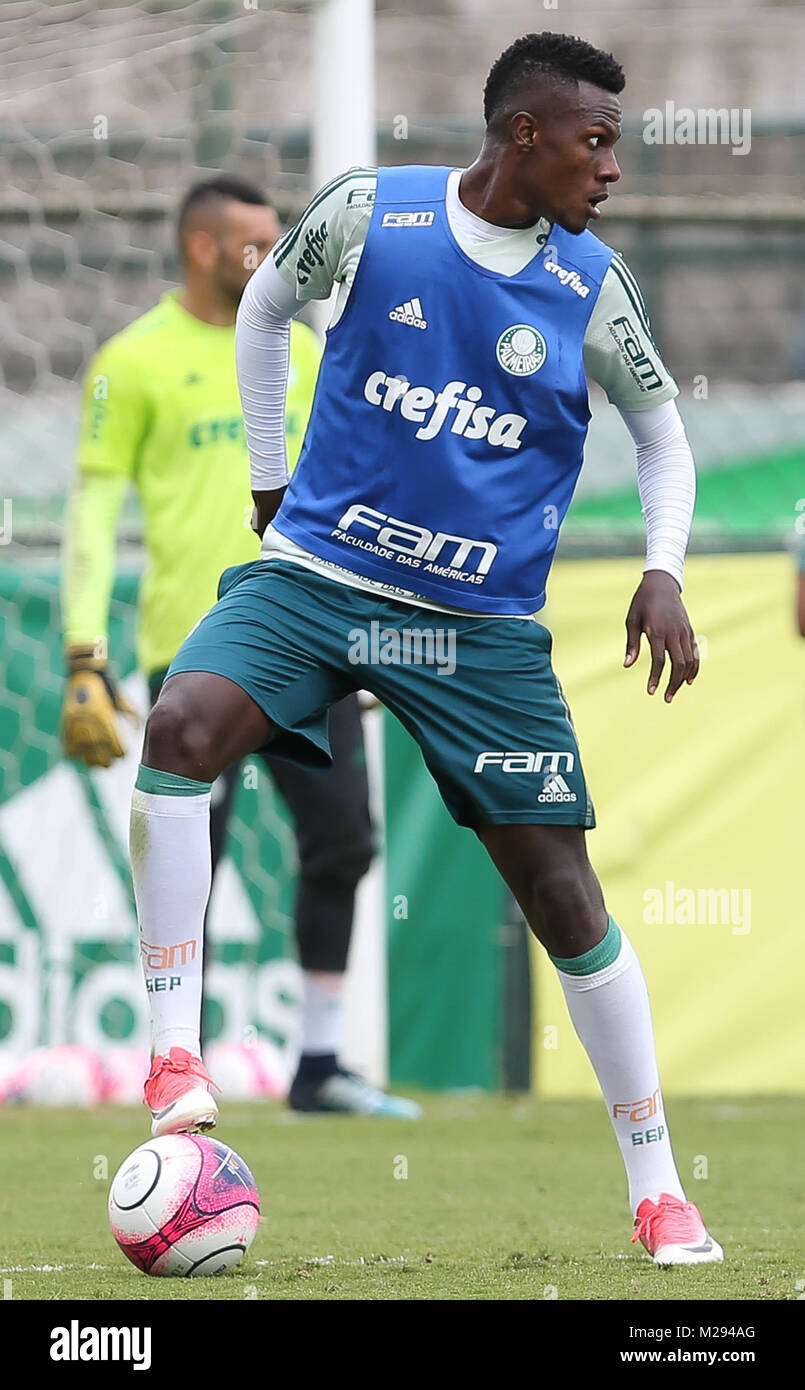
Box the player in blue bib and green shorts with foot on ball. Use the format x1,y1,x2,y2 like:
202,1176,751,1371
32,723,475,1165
132,33,723,1265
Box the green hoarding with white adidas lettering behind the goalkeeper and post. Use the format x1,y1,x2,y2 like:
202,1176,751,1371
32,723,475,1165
0,555,502,1087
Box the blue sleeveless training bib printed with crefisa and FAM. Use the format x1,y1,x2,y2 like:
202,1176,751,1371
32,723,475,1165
274,165,613,614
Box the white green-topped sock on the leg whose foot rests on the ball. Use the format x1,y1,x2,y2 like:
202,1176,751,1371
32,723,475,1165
131,765,211,1056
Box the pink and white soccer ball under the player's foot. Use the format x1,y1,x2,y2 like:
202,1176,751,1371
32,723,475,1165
108,1134,260,1276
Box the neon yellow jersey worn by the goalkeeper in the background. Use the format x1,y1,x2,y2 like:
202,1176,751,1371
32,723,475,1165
64,291,321,674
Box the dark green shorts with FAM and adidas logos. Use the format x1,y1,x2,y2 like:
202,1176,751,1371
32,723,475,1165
167,560,595,828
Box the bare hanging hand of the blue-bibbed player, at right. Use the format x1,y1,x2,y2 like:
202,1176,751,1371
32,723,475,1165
623,570,699,705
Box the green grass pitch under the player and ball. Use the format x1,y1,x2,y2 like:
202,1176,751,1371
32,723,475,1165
0,1095,805,1300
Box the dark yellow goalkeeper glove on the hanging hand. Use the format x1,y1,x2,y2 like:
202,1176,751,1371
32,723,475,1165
61,646,139,767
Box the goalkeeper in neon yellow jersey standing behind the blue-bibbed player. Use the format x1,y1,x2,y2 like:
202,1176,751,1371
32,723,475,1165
63,177,418,1116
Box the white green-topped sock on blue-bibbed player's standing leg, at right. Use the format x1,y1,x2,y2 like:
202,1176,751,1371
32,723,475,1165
551,917,685,1213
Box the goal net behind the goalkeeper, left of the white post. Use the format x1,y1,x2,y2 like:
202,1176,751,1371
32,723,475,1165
0,0,323,1088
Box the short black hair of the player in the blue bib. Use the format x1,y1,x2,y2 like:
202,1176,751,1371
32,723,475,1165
484,31,626,125
